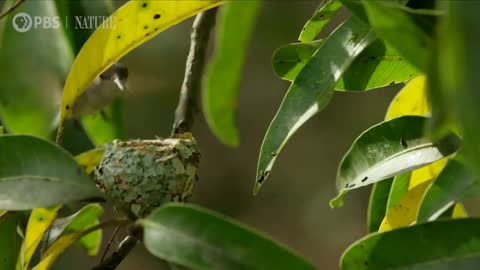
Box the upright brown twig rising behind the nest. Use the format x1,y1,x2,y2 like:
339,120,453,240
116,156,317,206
172,8,217,134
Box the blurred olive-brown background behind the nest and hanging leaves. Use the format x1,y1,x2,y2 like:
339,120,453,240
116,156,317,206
0,0,399,270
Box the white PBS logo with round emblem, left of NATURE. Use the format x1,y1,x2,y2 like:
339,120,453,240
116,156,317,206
12,12,60,33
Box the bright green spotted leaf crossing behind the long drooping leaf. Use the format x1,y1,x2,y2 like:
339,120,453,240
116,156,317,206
272,40,420,91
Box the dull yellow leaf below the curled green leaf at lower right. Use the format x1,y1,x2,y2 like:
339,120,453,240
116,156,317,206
378,181,432,232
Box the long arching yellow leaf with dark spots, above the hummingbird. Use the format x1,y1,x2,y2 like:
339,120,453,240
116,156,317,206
57,0,223,142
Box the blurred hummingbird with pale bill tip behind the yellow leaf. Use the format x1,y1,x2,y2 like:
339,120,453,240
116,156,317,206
71,62,128,119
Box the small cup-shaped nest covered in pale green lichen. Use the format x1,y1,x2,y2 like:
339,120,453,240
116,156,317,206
95,134,200,218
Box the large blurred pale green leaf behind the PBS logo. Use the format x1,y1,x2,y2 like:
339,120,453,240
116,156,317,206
0,1,73,139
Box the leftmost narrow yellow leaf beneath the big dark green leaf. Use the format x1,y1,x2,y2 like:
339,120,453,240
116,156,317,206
17,206,61,269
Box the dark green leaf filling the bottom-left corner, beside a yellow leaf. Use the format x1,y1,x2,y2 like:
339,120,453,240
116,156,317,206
0,213,22,270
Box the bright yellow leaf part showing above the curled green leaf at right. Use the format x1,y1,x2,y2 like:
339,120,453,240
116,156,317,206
385,76,430,120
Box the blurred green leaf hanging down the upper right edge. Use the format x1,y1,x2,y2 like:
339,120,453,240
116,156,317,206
432,1,480,177
